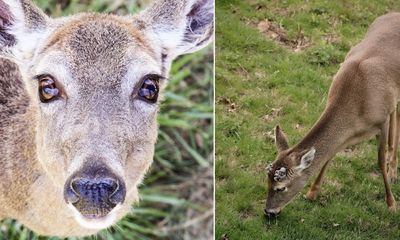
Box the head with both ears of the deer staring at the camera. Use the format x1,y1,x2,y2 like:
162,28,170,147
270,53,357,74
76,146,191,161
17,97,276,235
0,0,213,229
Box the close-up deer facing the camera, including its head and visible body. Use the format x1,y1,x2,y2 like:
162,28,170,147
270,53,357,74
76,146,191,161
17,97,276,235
0,0,214,237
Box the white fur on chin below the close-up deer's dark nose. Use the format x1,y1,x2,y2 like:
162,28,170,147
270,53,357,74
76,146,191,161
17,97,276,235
68,203,121,230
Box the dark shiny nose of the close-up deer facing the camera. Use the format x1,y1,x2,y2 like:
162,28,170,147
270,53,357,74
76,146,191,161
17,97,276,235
64,168,126,219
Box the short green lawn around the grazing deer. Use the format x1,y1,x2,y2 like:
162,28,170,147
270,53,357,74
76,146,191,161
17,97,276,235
216,0,400,240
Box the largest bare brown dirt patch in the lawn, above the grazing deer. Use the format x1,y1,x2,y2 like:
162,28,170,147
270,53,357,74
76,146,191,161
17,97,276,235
242,19,310,53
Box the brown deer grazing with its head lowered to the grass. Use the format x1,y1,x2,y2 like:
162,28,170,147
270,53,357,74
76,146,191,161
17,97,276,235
264,13,400,219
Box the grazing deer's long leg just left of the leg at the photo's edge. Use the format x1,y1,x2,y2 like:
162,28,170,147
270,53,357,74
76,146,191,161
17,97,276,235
378,121,396,211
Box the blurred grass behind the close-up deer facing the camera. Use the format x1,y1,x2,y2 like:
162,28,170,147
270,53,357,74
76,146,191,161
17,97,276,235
0,0,213,240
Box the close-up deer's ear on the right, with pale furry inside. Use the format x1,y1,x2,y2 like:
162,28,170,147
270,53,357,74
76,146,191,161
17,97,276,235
137,0,214,58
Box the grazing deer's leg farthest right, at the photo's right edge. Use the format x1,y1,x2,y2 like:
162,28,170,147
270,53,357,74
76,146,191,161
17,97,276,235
388,107,400,183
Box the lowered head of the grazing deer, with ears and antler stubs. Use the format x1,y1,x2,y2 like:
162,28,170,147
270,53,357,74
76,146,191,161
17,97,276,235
264,127,316,218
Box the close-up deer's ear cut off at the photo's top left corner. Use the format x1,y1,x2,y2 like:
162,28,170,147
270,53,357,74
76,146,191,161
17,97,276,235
0,0,48,61
